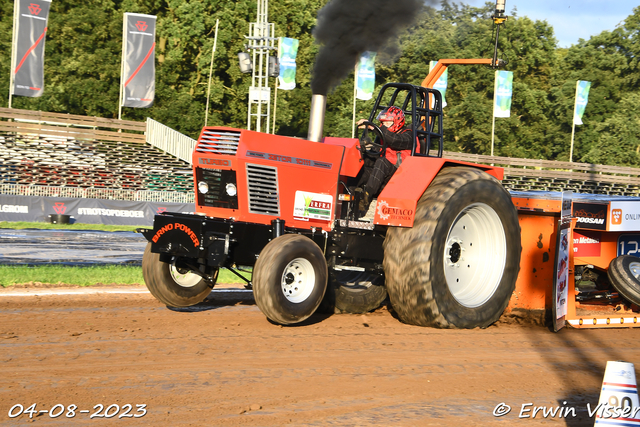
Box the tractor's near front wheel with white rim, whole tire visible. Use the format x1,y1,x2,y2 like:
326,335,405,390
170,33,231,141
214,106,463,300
253,234,327,325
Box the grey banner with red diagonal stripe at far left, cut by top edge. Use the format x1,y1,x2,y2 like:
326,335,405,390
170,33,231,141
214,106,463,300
11,0,51,98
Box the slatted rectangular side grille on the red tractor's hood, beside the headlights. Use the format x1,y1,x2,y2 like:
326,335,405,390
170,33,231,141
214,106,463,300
247,163,280,215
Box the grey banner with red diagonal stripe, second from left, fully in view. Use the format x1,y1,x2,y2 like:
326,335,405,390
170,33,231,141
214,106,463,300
121,13,156,108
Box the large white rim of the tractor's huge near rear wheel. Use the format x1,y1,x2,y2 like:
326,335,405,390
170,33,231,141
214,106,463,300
444,203,507,308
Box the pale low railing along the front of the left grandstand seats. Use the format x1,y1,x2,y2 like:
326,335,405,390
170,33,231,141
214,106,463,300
0,184,195,203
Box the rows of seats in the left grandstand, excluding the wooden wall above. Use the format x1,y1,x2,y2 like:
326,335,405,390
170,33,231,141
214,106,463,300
0,132,193,193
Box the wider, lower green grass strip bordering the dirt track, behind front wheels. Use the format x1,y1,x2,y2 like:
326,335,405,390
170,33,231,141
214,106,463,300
0,265,251,288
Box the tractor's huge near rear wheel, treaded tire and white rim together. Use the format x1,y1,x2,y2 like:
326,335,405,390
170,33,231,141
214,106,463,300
383,167,521,328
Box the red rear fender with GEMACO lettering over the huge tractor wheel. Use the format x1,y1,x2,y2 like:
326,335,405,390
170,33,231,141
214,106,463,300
373,156,504,227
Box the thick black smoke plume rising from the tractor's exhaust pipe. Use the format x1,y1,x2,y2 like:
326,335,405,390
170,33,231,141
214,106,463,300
311,0,435,95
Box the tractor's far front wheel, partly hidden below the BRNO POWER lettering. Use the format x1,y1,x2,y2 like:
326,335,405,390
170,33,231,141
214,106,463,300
142,243,218,307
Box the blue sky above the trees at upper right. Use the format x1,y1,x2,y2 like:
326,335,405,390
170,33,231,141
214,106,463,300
462,0,640,47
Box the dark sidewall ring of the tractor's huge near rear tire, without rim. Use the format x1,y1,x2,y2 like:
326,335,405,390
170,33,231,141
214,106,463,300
430,180,520,328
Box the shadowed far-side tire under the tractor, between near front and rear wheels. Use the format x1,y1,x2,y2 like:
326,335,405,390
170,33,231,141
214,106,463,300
327,270,387,314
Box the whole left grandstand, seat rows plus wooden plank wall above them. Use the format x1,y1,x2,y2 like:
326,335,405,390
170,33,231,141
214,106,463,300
0,108,193,199
